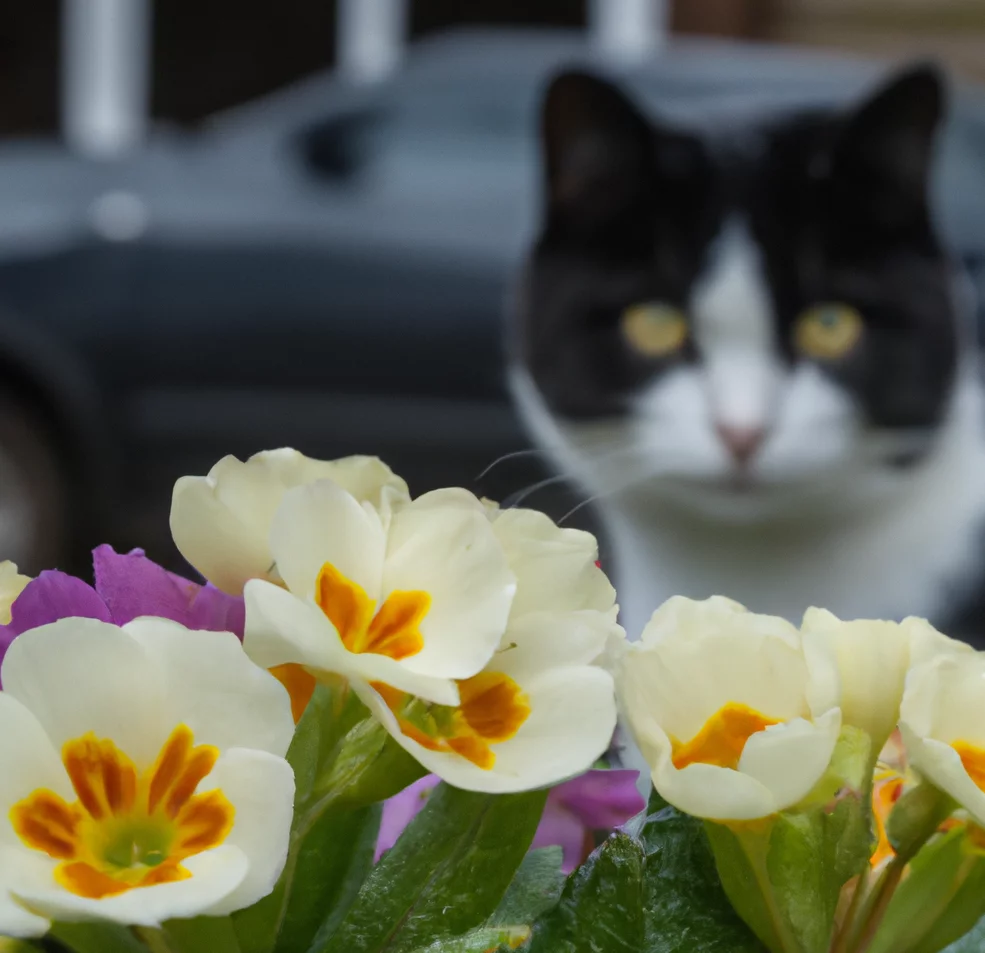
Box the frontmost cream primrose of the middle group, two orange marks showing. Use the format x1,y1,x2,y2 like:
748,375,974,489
244,480,516,705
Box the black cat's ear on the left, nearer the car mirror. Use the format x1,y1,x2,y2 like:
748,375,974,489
541,71,654,218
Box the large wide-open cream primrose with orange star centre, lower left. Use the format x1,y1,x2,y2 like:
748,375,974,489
0,618,294,937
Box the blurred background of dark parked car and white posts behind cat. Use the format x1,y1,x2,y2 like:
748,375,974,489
0,0,985,571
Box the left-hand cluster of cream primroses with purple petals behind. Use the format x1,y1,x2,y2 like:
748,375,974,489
0,450,620,937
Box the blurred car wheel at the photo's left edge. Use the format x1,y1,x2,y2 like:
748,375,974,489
0,395,70,575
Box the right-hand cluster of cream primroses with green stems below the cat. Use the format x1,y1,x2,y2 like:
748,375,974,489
616,597,985,953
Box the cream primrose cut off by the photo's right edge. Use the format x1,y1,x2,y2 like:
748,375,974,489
900,652,985,825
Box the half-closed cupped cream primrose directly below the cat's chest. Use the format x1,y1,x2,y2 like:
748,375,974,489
618,596,841,821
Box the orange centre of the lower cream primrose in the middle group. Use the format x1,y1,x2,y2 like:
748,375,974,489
373,672,531,771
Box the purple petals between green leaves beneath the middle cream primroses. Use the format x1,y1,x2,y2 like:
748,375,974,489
376,771,645,873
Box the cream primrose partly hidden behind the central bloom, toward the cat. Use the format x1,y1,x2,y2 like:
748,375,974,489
358,503,625,793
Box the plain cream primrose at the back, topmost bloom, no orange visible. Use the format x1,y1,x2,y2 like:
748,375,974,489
171,448,410,595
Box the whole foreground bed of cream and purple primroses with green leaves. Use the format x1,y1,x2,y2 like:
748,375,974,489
0,450,985,953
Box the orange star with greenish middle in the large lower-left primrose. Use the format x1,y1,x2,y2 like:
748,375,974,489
10,725,235,900
